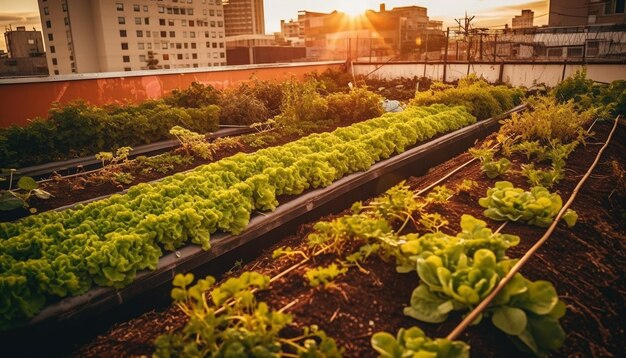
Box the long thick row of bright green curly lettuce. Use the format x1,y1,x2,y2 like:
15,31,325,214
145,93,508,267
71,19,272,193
0,105,475,328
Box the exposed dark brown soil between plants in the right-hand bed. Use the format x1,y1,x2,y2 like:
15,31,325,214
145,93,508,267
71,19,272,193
75,123,626,357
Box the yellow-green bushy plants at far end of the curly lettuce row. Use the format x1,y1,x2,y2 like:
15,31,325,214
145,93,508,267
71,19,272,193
411,75,523,120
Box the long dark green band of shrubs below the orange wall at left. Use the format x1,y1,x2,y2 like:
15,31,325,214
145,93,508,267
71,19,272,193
0,101,220,168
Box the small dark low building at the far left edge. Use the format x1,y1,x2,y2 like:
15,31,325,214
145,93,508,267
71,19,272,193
0,26,48,77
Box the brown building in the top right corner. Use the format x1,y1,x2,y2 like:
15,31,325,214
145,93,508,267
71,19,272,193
548,0,626,27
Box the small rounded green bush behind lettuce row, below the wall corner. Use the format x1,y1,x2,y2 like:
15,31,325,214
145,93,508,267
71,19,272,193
326,87,383,123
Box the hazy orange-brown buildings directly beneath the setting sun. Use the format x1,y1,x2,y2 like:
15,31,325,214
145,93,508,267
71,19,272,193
298,4,445,60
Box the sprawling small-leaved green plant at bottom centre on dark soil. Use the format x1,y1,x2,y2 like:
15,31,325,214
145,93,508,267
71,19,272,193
155,272,342,357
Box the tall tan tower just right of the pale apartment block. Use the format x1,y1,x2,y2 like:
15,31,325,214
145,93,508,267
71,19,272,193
223,0,265,36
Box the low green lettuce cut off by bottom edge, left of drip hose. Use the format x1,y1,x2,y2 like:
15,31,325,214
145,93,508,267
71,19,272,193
371,327,470,358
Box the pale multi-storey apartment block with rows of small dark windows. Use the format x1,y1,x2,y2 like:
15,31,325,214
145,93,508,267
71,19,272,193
38,0,226,75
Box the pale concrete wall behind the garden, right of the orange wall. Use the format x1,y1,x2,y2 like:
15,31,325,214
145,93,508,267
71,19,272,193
354,63,626,87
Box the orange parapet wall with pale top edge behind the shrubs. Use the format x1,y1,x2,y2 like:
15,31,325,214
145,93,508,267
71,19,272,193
0,62,344,128
